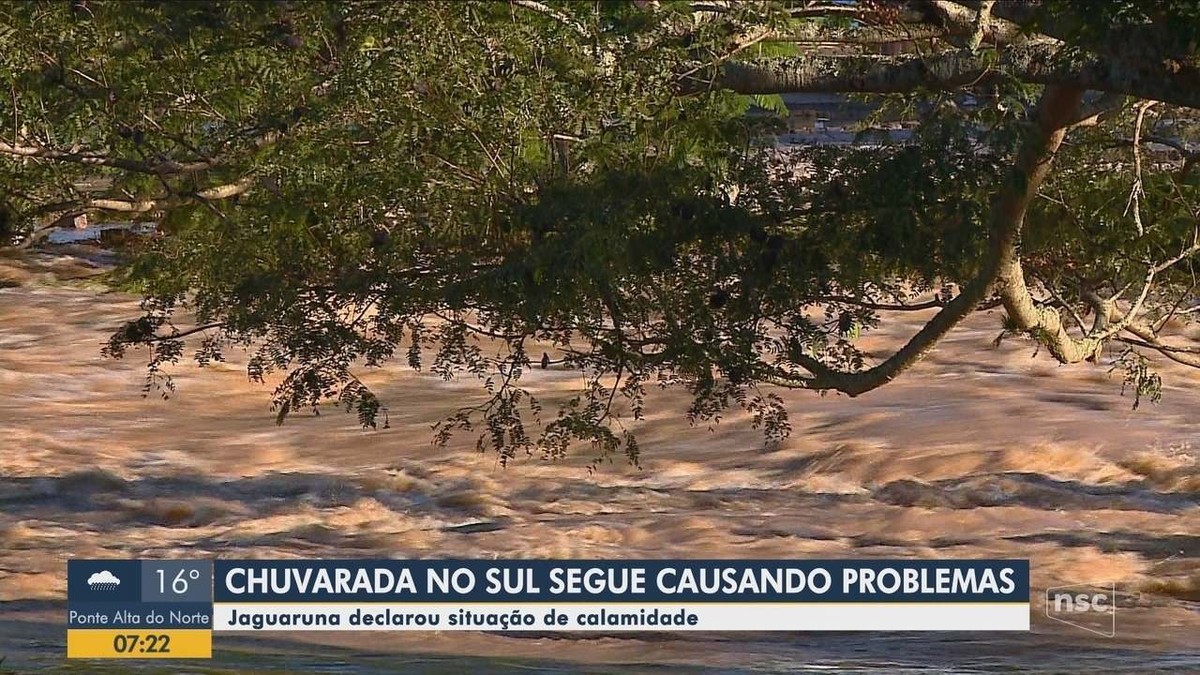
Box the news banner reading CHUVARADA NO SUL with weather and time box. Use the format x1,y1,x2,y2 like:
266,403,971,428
67,560,1030,658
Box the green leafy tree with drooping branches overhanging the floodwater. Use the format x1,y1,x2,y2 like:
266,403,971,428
0,0,1200,461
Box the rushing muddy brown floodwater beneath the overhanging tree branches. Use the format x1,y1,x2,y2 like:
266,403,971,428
0,249,1200,673
